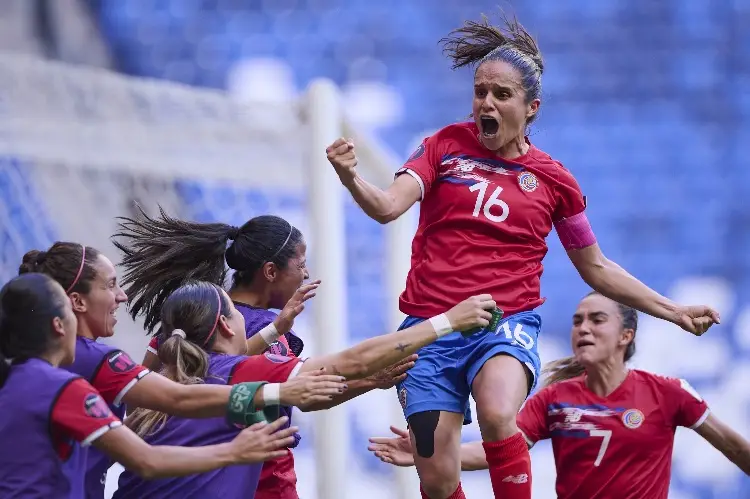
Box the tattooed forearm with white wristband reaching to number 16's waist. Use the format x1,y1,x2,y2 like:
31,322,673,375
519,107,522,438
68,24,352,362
302,295,495,379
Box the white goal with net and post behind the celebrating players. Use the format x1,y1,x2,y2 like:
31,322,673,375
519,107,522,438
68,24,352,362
0,54,417,499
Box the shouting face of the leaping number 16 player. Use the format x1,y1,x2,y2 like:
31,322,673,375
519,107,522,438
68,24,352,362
472,61,539,151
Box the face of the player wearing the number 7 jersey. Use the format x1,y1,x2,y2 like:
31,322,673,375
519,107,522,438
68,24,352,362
571,294,629,366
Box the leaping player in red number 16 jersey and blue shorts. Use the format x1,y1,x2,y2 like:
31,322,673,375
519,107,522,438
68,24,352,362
327,11,719,499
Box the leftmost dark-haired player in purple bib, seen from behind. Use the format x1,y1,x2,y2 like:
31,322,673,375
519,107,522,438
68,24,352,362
0,273,294,499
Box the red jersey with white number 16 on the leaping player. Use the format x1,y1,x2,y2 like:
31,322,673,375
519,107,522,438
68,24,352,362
396,123,585,317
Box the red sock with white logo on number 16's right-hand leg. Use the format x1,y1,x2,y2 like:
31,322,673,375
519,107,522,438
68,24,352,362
482,433,531,499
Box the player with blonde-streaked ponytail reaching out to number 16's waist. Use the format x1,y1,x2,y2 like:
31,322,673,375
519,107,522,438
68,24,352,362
110,282,486,499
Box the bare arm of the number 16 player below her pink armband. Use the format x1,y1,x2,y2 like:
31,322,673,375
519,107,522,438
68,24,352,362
567,243,720,335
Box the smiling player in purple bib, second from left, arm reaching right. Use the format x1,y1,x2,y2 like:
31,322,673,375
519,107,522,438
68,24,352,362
19,242,343,499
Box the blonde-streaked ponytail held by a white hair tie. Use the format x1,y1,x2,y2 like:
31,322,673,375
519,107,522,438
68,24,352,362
125,329,208,438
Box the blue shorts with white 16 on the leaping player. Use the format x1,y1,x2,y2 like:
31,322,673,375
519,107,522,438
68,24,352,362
397,312,542,424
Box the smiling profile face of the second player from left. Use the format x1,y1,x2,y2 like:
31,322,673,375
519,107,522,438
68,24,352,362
78,254,128,338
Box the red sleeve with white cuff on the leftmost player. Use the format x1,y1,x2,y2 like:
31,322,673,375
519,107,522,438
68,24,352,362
51,378,122,446
